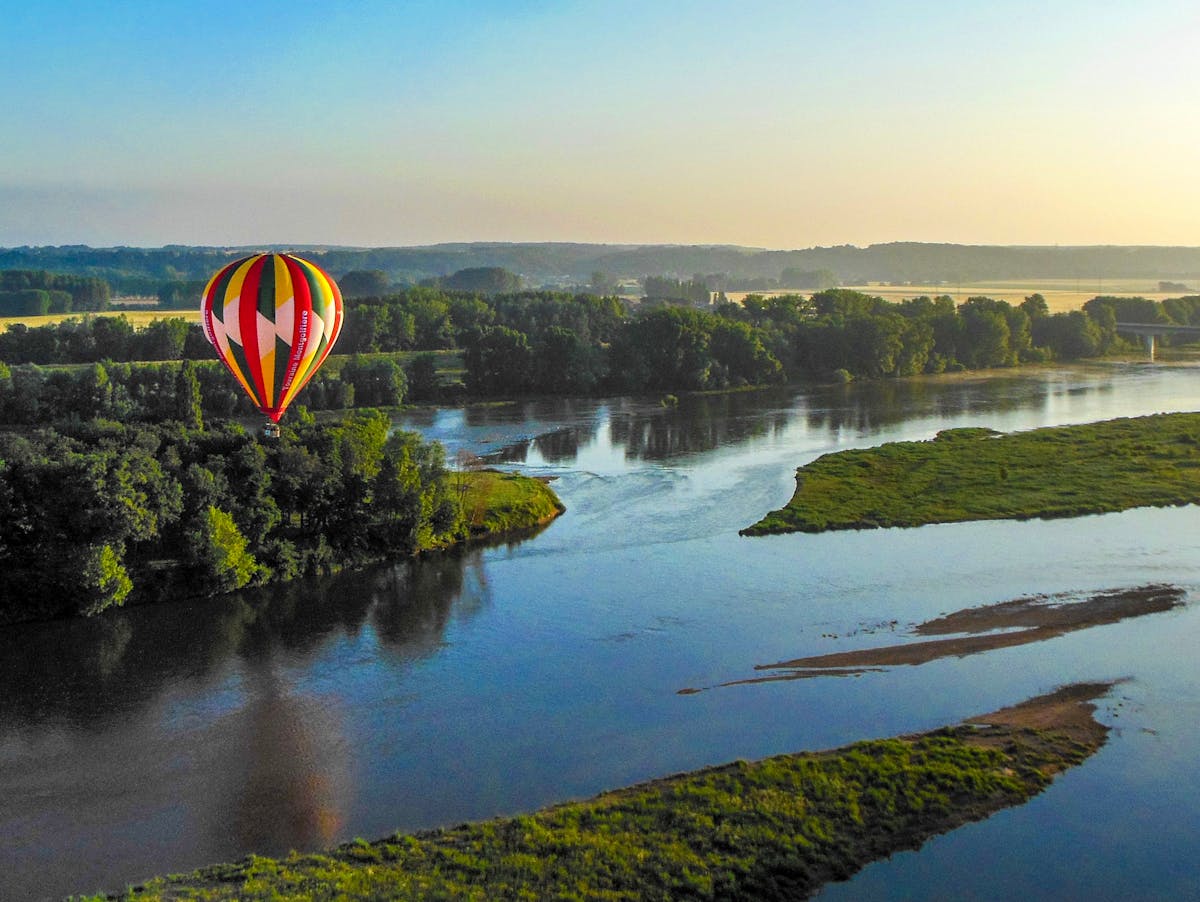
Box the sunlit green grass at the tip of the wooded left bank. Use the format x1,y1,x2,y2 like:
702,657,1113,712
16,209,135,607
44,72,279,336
450,470,566,537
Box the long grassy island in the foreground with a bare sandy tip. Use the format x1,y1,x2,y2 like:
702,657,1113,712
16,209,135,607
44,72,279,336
82,684,1111,900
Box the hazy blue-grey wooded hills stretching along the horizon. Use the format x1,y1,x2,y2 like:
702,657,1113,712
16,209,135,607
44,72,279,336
0,241,1200,289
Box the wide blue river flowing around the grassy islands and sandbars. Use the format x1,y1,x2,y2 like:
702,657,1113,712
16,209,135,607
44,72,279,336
0,363,1200,900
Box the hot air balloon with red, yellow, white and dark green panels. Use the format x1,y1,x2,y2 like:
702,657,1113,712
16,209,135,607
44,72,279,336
200,254,343,424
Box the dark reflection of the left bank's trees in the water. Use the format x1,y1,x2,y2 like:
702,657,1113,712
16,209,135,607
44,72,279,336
0,548,486,760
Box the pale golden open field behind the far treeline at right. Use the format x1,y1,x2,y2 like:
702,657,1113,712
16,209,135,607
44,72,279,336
726,278,1200,313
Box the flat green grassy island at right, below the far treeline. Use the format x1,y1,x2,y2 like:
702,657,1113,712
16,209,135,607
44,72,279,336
742,414,1200,535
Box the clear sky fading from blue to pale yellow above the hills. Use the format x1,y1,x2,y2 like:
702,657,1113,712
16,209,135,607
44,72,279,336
0,0,1200,248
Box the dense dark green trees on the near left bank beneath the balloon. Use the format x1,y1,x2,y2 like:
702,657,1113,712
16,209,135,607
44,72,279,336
0,411,466,623
